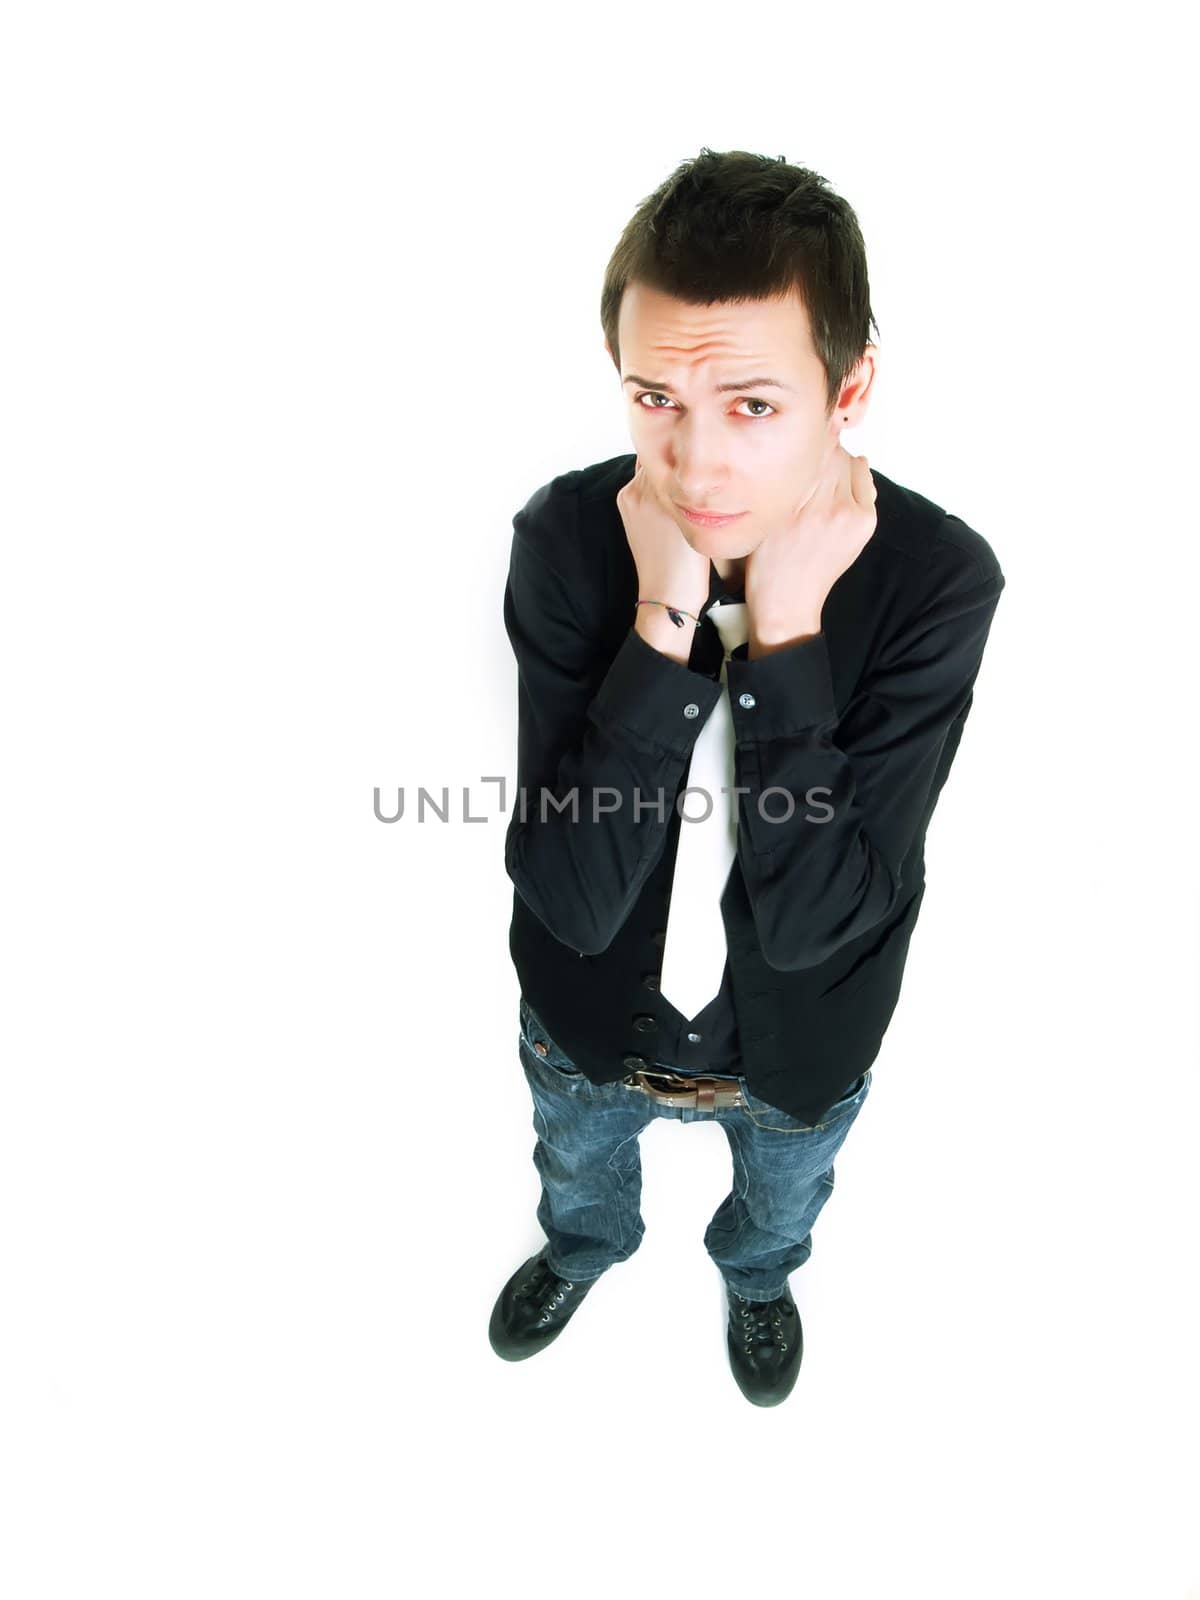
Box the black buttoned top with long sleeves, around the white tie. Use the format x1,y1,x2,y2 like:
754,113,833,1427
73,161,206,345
504,454,1005,1122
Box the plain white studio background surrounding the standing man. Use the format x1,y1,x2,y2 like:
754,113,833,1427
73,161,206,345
0,0,1200,1600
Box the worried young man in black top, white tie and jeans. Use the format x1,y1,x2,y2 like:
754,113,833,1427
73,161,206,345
490,149,1005,1405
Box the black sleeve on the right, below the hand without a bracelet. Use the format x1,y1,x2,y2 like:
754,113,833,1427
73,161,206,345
728,544,1005,971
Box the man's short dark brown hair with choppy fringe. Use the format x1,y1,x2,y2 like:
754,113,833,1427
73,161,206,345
600,146,878,414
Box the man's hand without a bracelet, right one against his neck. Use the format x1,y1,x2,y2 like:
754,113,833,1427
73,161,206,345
746,440,877,654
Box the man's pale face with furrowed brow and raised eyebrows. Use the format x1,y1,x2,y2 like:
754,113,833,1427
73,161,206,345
610,283,874,562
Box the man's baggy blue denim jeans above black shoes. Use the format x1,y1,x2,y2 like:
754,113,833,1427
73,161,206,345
520,995,870,1301
